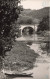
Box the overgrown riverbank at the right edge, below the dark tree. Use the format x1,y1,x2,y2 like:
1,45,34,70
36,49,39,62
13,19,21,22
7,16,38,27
37,30,50,55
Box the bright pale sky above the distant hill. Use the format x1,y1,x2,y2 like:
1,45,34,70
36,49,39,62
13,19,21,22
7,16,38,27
21,0,50,9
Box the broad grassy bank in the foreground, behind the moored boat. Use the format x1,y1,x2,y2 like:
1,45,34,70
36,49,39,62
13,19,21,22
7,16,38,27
4,41,38,70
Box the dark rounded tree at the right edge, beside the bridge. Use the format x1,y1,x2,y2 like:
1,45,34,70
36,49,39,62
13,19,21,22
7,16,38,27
37,16,49,32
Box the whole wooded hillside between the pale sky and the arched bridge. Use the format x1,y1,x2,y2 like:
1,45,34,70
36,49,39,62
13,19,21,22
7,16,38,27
19,7,50,23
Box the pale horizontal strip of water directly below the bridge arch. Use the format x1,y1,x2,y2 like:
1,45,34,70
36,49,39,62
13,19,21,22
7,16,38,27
16,34,44,42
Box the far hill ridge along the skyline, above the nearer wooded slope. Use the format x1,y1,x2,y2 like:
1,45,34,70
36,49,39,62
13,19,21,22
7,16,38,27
21,7,50,19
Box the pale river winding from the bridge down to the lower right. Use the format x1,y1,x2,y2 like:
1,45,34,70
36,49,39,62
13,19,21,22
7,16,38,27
16,34,50,79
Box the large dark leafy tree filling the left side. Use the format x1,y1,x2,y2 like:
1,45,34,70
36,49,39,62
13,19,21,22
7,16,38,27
0,0,21,57
